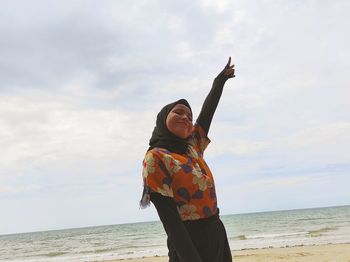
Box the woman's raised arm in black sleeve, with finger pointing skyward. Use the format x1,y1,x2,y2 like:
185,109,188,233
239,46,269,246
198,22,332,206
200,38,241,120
196,57,235,134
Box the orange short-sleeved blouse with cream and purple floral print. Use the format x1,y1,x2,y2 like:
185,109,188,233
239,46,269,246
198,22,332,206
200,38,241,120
142,124,217,221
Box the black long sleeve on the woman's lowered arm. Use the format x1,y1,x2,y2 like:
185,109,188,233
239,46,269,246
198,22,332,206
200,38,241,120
151,193,202,262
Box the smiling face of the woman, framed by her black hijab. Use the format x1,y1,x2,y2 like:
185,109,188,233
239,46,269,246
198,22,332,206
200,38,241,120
166,104,193,139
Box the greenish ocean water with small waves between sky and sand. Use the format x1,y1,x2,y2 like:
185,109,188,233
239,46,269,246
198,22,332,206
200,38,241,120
0,206,350,262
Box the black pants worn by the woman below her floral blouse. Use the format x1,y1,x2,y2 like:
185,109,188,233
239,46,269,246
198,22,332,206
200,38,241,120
167,215,232,262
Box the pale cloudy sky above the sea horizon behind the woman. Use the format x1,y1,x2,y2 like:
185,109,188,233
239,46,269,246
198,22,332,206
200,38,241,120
0,0,350,234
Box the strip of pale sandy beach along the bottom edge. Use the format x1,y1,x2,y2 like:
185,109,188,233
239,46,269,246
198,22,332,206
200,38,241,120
105,243,350,262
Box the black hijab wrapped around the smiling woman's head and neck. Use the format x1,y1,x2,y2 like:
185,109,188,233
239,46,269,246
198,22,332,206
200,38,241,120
148,99,192,154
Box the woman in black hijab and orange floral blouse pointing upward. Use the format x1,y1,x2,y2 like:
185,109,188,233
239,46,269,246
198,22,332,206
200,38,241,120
141,57,235,262
